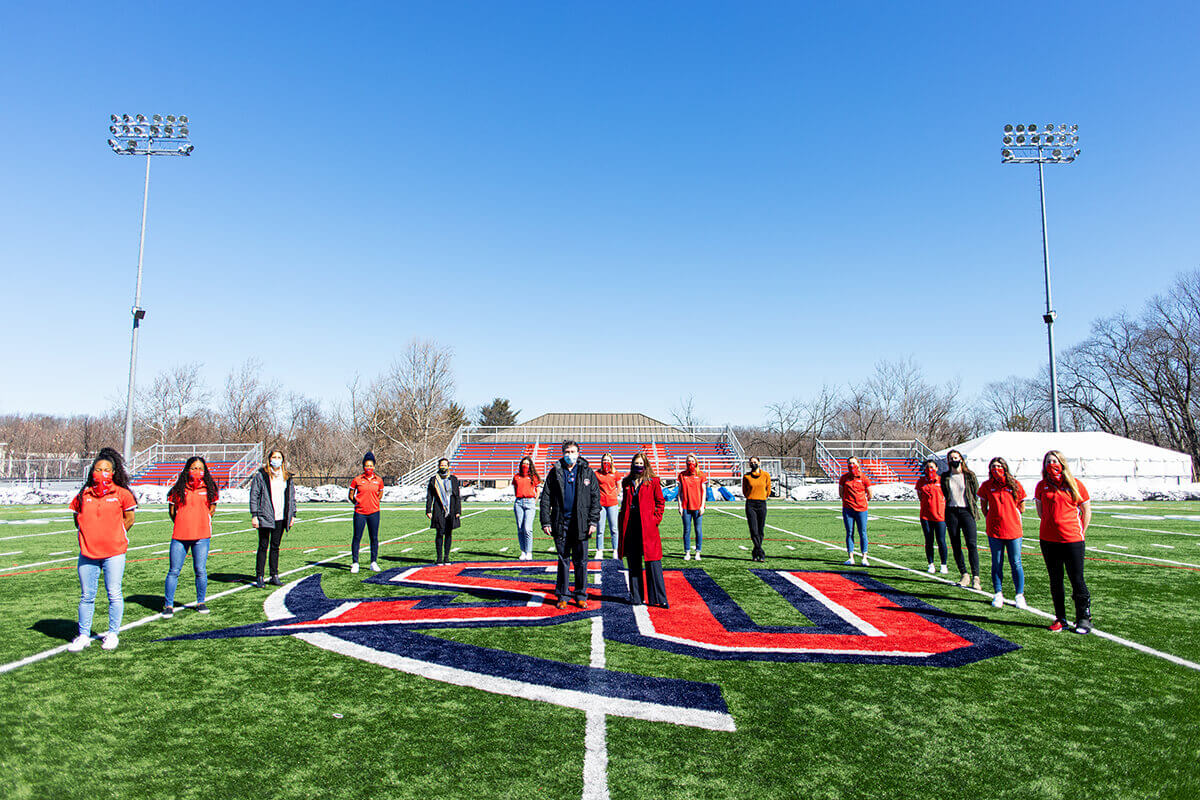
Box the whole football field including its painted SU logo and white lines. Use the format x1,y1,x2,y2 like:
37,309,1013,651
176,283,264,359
0,503,1200,800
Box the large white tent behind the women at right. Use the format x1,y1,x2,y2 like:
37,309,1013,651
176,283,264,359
938,431,1192,486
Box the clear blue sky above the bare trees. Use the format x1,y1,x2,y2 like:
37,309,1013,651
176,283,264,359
0,0,1200,423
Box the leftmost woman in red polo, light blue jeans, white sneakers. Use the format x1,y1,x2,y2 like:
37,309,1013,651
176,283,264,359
67,447,138,652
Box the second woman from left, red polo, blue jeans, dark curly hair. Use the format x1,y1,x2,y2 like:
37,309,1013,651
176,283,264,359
162,456,217,619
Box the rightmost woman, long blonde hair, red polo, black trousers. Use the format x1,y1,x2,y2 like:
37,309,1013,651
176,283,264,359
1033,450,1092,633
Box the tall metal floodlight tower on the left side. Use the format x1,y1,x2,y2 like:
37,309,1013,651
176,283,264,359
108,114,193,464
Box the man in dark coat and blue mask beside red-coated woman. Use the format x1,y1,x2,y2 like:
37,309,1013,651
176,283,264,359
539,439,600,608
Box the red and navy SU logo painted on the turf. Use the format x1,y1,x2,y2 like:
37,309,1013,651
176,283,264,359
164,560,1018,730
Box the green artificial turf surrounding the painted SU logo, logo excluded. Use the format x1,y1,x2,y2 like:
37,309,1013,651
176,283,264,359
0,503,1200,800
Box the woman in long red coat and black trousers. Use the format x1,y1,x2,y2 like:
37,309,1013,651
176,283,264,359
617,453,667,608
